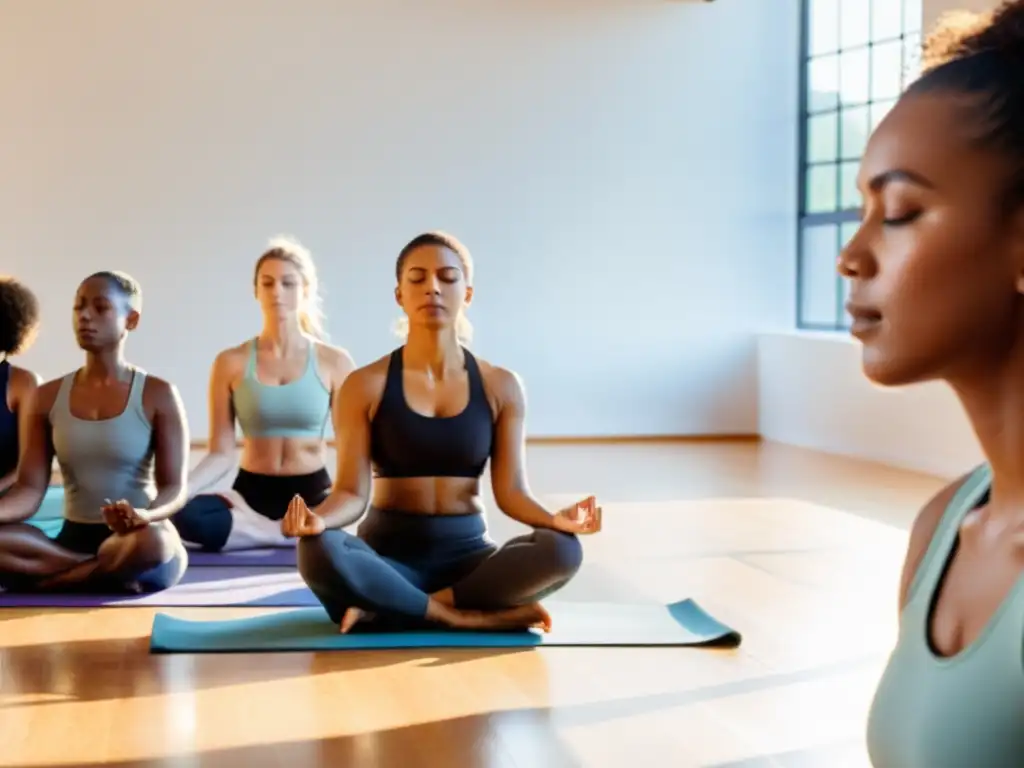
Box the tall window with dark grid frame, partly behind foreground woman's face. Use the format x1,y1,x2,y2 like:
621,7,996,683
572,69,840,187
797,0,922,331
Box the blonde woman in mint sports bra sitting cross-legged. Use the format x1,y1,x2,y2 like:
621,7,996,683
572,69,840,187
173,239,355,552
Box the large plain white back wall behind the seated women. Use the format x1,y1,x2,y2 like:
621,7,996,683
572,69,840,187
0,0,799,437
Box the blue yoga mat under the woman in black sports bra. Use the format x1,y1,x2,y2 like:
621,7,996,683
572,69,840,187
150,600,741,653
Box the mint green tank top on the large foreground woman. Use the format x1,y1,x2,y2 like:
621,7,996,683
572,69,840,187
867,466,1024,768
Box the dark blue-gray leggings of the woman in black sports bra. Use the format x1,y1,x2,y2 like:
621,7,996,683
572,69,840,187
297,508,583,624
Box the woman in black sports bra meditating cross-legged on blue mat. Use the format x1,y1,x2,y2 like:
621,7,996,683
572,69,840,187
282,232,600,632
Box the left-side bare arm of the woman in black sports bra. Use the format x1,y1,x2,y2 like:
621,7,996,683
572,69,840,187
313,372,373,528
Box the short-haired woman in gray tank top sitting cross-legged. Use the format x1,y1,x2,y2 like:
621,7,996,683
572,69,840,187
0,272,188,592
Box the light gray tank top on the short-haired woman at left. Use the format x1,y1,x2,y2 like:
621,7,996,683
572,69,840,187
50,369,157,523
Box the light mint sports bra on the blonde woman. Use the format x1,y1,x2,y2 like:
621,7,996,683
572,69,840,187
231,339,331,438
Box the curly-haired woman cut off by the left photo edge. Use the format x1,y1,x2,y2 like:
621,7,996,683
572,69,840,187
0,275,41,495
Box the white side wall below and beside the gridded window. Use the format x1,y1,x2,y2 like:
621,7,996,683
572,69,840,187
758,0,997,477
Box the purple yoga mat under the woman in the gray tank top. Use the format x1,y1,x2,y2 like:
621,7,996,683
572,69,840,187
0,564,319,608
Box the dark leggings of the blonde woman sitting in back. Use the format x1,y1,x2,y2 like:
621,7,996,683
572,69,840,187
171,469,331,552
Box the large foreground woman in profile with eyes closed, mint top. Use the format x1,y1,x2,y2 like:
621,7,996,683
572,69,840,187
839,0,1024,768
